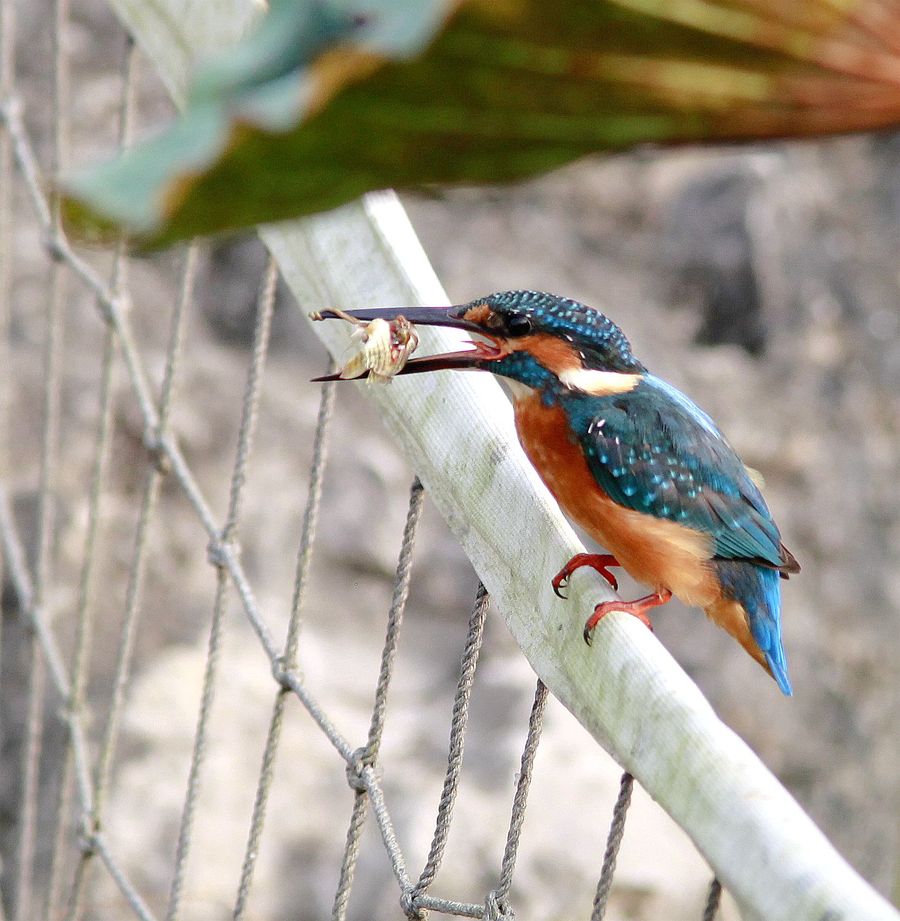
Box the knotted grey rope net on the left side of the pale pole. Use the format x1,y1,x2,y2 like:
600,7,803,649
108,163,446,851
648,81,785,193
0,0,736,921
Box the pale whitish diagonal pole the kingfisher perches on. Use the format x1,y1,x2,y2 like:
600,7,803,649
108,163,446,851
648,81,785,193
98,0,900,921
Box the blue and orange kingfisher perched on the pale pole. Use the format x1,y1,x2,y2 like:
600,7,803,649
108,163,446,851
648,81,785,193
318,291,800,696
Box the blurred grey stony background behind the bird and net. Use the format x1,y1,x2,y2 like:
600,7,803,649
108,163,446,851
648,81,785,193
0,0,900,921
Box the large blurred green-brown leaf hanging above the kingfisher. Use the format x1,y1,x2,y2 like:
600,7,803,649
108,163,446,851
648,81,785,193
64,0,900,245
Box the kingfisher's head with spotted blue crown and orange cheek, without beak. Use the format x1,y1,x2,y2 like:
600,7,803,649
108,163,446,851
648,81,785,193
454,291,645,376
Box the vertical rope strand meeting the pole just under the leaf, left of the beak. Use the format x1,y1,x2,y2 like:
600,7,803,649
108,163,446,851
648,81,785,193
166,256,278,921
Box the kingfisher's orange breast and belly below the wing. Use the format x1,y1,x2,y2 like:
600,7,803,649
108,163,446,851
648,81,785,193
515,393,722,608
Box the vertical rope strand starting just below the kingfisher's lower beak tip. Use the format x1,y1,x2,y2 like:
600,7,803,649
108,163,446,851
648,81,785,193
233,374,335,921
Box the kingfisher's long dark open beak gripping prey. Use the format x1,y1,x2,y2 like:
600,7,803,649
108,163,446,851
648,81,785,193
313,306,504,381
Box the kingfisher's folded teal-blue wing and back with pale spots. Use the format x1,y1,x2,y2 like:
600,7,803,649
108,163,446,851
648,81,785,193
562,375,796,570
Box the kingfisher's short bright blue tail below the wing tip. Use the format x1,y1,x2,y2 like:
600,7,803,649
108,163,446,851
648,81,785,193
718,560,794,697
